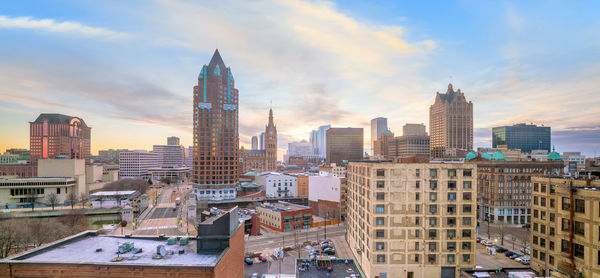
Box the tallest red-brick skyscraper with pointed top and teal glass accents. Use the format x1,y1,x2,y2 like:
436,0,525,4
193,50,239,199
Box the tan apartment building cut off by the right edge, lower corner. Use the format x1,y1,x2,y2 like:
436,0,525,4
531,177,600,278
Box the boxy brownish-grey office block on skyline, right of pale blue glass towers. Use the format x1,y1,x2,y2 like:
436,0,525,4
326,127,364,165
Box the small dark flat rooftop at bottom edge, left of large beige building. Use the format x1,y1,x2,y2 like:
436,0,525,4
296,259,365,278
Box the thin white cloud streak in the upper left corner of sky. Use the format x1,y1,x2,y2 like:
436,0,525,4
0,15,129,39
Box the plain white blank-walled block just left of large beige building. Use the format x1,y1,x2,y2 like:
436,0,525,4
308,172,340,203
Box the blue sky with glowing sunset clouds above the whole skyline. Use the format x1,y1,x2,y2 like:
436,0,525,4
0,0,600,160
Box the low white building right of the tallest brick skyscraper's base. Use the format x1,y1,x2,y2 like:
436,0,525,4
255,172,298,198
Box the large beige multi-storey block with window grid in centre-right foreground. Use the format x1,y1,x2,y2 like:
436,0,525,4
346,161,477,278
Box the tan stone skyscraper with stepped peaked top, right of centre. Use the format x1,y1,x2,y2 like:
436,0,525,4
429,84,473,158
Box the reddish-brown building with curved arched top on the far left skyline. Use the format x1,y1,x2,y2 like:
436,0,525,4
29,113,91,164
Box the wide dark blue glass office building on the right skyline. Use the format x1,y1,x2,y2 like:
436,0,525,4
492,124,552,153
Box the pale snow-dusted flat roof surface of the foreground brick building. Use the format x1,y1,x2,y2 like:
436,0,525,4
5,231,221,267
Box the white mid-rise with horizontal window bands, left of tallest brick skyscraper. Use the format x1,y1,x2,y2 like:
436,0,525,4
119,150,159,179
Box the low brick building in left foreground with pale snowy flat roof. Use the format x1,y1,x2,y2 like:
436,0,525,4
0,207,244,278
